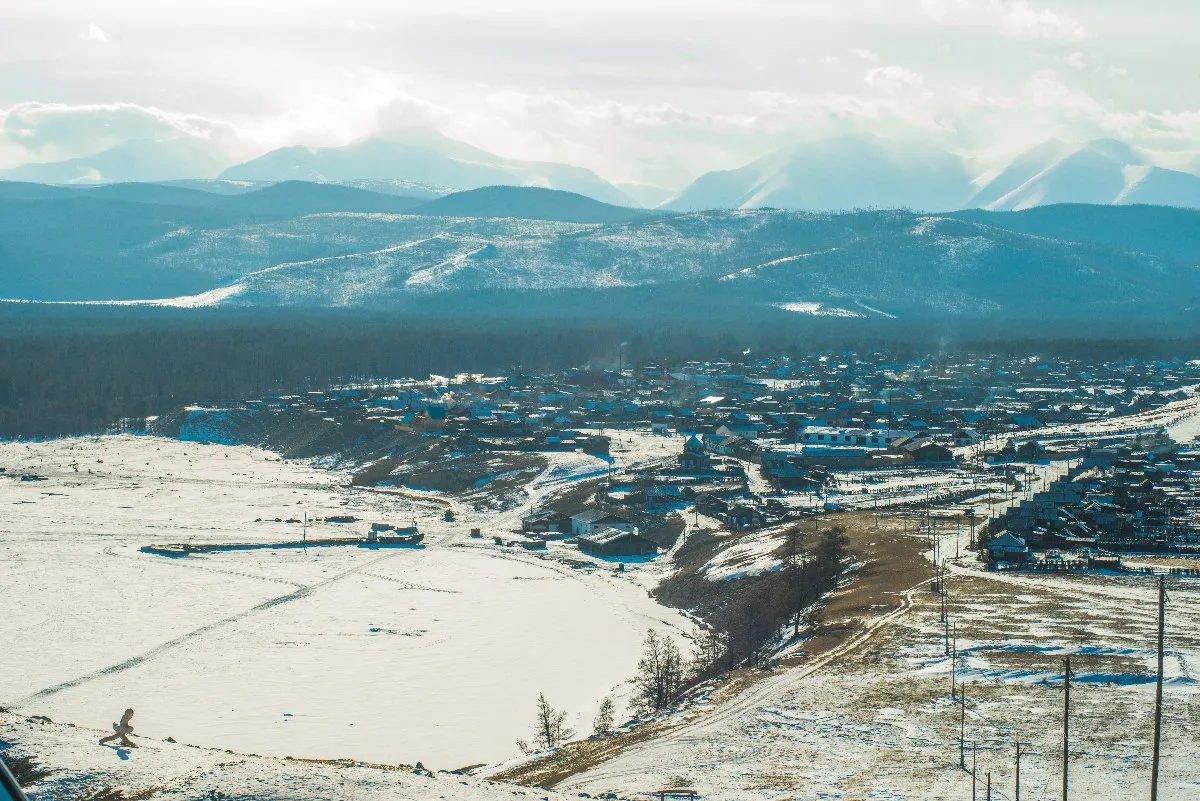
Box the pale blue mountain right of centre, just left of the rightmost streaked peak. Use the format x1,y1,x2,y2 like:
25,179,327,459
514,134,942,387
664,135,972,211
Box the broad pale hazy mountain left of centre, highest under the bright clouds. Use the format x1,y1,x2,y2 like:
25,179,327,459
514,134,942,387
221,130,638,206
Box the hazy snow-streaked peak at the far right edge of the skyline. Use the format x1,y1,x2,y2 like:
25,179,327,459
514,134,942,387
967,139,1200,211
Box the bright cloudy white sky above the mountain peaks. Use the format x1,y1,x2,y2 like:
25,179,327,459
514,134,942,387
0,0,1200,189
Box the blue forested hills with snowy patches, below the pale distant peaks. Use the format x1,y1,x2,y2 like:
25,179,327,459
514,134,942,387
0,181,1200,325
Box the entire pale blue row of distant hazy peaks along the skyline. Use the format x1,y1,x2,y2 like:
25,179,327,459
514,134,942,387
2,128,1200,211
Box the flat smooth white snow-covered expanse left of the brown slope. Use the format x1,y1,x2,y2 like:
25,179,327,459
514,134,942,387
0,436,690,769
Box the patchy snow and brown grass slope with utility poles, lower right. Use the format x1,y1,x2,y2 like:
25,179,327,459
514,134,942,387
559,522,1200,801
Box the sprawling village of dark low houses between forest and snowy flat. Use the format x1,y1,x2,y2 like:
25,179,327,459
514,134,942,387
164,353,1200,568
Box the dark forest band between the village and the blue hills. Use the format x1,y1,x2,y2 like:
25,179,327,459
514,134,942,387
7,306,1200,439
